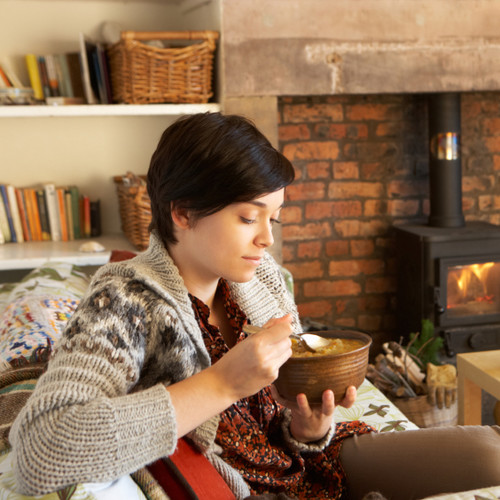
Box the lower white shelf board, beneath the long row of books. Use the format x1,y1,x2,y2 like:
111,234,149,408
0,234,138,271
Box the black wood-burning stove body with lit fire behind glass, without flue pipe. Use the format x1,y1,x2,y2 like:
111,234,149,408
395,222,500,356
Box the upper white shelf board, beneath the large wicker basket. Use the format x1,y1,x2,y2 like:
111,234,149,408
0,103,220,118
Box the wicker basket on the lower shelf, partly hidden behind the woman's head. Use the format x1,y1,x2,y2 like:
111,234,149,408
114,172,151,250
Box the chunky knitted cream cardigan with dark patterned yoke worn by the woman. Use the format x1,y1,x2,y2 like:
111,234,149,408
9,233,333,498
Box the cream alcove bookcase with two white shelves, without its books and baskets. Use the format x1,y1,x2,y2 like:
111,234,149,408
0,0,220,274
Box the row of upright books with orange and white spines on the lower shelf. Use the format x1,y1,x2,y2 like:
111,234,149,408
0,183,101,243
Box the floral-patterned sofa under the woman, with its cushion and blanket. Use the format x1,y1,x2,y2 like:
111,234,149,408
0,259,500,500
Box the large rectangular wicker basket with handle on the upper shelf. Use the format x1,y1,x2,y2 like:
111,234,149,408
108,31,219,104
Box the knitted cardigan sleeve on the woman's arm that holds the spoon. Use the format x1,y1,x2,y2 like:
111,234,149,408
9,278,177,495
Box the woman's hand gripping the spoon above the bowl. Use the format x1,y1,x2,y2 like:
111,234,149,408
211,314,292,401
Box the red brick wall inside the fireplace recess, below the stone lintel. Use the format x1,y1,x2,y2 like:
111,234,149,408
279,93,500,350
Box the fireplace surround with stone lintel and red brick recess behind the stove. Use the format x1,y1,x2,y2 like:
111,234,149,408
221,0,500,352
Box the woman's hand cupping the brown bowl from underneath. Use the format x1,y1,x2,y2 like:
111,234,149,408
271,385,357,443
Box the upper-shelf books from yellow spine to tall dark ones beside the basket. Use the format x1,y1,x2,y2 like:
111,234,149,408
25,33,113,104
